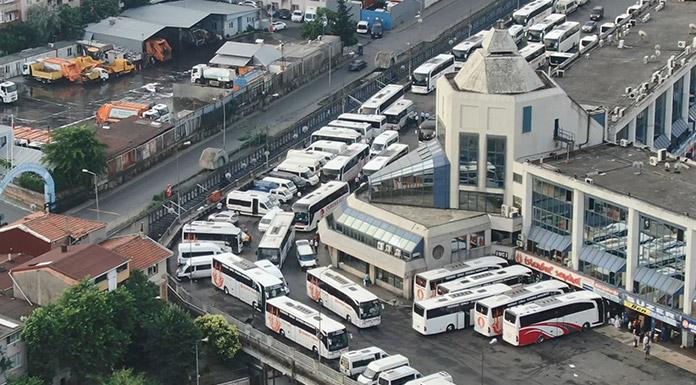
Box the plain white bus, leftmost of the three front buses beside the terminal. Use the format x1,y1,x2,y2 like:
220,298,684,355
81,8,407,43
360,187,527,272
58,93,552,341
411,283,510,335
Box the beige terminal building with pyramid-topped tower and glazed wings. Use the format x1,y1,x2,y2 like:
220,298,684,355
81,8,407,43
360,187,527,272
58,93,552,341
319,0,696,346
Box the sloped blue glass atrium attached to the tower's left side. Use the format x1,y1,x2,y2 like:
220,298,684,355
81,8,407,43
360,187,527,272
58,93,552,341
369,141,450,208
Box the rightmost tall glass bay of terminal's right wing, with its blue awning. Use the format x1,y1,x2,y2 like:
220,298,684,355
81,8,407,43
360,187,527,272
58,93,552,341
633,215,686,308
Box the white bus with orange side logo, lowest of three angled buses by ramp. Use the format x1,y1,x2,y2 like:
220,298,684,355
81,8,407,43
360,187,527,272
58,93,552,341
266,296,348,360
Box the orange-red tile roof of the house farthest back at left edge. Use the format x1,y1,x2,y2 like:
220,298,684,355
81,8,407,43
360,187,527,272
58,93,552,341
0,211,106,242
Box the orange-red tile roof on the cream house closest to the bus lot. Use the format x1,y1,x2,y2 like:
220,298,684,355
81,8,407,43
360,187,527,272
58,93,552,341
100,234,174,270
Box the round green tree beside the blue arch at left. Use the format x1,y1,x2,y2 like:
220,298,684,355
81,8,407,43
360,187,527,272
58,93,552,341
43,126,106,187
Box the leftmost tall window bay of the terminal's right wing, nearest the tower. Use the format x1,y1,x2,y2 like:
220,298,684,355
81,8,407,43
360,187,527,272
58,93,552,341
532,178,573,235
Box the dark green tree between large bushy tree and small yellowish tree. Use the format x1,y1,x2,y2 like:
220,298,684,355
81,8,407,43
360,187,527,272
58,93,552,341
141,305,201,384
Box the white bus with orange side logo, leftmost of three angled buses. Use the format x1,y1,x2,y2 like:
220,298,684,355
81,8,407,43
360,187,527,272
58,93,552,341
210,253,288,311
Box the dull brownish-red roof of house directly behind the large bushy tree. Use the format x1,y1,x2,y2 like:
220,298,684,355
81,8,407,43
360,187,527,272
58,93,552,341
10,244,128,281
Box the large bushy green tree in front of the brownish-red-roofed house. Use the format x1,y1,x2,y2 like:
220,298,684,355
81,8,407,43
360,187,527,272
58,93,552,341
22,281,135,380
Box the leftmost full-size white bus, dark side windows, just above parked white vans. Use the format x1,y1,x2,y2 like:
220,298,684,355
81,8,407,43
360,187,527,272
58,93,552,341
181,221,244,254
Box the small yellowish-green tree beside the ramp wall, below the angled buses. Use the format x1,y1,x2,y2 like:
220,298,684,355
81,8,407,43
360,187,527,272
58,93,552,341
194,314,242,362
